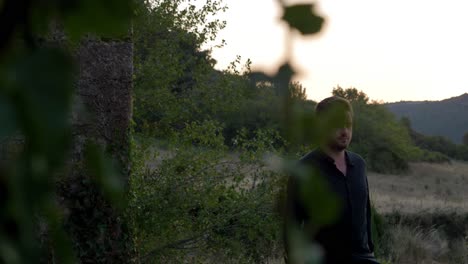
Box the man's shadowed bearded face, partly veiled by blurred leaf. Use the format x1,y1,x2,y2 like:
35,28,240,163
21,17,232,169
328,111,353,151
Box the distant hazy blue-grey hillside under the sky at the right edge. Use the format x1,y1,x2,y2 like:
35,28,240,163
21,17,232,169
387,93,468,143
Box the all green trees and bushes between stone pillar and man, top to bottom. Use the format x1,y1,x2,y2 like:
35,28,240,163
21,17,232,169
130,1,332,263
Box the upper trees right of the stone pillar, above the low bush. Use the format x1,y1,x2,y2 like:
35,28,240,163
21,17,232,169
134,1,316,145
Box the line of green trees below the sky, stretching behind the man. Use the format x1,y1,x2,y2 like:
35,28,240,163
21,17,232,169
134,1,468,176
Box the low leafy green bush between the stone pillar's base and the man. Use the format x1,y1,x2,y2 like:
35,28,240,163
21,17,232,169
131,121,282,263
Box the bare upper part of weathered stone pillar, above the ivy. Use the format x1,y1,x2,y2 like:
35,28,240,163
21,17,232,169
73,39,133,167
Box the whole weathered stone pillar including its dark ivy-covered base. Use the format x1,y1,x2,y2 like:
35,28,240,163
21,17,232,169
58,38,133,263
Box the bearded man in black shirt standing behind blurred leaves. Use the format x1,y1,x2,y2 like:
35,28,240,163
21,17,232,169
285,96,378,264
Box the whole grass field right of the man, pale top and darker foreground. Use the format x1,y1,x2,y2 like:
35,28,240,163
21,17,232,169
368,161,468,264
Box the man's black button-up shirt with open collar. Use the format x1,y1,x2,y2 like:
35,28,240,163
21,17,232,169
287,149,374,263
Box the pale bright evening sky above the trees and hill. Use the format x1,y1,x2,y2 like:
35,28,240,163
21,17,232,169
197,0,468,102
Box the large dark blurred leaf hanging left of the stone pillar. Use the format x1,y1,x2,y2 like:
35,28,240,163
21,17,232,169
10,48,74,160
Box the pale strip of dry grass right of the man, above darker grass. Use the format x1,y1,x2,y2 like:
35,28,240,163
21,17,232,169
368,161,468,213
